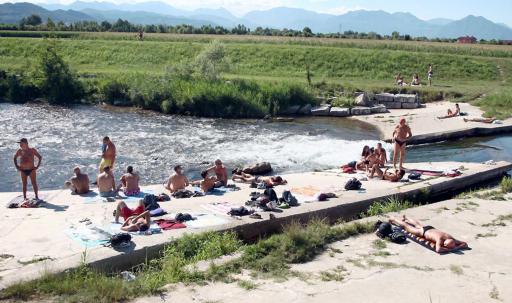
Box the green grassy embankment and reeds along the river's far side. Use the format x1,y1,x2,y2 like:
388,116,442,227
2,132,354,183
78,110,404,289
0,32,512,118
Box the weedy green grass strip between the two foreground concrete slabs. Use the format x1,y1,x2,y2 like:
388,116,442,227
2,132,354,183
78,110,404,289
0,220,374,303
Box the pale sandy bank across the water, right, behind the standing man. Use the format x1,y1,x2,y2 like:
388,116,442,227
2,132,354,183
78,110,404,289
351,101,512,145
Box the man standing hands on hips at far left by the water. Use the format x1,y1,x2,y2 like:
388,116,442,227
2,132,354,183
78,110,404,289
14,138,43,200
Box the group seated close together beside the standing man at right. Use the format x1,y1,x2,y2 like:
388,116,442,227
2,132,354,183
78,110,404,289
342,143,405,182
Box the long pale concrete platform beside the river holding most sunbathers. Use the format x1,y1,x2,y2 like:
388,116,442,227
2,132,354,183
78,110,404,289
0,162,512,288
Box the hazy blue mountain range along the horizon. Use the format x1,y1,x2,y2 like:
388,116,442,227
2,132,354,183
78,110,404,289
0,1,512,40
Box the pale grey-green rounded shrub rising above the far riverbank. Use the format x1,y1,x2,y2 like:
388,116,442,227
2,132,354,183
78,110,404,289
195,40,230,81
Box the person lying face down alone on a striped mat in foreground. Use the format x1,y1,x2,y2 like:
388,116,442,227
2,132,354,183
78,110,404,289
389,215,468,253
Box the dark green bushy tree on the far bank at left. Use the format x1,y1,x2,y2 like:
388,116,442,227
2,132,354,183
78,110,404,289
39,40,84,104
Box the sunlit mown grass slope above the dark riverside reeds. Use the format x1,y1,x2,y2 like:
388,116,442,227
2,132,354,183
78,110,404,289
0,32,512,118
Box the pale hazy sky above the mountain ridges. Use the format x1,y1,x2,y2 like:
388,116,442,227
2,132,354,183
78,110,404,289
0,0,512,26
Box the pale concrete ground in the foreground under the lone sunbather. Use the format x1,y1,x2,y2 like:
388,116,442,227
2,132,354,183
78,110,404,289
134,194,512,303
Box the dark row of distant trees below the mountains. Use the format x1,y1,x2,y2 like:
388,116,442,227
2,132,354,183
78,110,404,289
0,14,503,44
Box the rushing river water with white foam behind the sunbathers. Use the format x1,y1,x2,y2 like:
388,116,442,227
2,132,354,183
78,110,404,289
0,103,512,191
